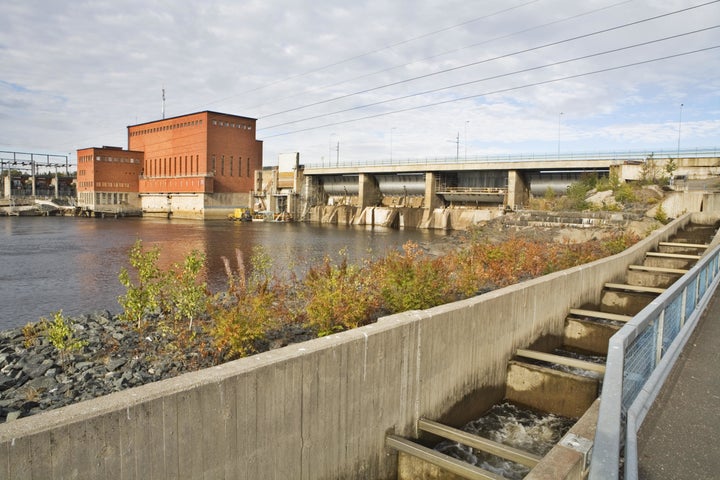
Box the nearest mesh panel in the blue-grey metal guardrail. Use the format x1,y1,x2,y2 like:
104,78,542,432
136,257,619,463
622,319,657,411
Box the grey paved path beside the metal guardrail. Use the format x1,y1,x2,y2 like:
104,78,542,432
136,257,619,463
638,288,720,480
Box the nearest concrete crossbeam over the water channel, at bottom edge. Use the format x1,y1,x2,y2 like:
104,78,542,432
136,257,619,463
385,434,504,480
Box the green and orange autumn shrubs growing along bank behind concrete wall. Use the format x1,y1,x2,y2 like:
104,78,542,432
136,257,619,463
115,234,639,360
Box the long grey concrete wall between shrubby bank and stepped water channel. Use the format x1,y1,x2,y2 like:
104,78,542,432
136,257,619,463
0,216,688,480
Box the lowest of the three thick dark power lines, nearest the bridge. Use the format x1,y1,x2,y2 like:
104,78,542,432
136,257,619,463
265,45,720,138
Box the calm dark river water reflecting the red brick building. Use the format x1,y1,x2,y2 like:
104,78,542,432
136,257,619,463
0,217,445,329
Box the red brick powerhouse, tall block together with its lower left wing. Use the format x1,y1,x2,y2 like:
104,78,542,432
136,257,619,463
78,111,262,218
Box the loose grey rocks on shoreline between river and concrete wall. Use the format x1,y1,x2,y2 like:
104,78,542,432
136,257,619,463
0,311,317,422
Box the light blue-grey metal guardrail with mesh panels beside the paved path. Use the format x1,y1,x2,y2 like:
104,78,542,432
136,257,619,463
589,238,720,480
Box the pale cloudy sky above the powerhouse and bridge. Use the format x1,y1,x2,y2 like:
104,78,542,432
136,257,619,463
0,0,720,165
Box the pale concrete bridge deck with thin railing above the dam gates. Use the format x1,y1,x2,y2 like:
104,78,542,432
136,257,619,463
305,147,720,169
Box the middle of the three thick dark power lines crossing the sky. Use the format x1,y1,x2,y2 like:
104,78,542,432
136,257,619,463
262,25,720,130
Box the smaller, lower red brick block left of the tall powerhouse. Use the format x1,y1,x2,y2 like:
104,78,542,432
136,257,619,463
77,147,143,213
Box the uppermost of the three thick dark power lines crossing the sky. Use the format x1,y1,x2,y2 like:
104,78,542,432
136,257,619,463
258,0,720,123
